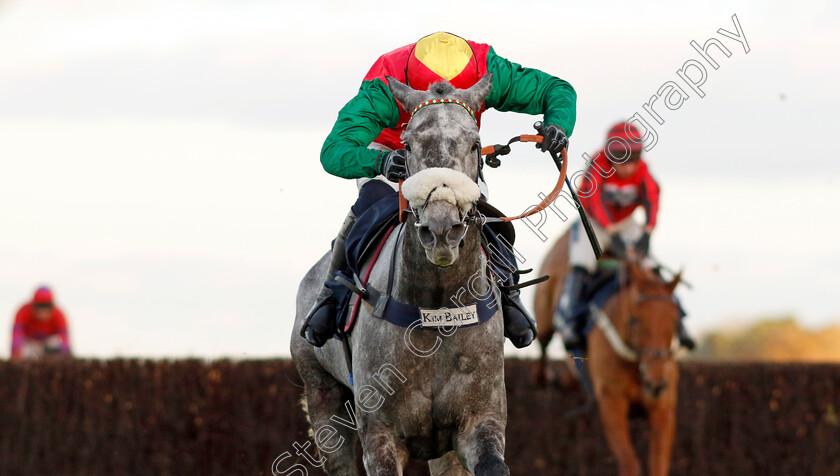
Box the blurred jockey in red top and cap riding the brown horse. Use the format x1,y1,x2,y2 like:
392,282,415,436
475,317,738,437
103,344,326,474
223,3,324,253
554,122,695,350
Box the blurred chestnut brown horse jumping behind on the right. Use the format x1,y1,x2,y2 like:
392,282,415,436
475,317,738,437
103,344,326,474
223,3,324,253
535,229,680,476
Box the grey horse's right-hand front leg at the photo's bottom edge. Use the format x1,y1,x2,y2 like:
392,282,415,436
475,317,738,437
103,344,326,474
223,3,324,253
458,417,510,476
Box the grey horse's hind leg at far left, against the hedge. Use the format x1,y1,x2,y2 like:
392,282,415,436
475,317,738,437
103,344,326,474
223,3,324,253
295,356,359,476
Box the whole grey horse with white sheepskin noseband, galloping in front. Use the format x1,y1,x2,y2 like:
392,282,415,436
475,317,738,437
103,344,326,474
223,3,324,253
291,75,510,476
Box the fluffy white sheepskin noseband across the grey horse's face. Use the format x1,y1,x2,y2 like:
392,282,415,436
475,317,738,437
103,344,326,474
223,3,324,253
402,167,481,213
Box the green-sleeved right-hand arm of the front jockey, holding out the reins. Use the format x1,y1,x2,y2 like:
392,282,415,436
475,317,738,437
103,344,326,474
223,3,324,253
484,47,577,137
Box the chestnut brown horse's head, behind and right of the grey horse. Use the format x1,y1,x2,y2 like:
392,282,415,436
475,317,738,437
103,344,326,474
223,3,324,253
627,262,680,398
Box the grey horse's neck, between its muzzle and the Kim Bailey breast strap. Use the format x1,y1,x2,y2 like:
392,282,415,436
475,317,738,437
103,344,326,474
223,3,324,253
393,222,489,308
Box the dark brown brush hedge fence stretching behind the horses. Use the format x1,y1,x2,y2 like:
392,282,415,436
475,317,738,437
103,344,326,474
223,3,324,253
0,360,840,476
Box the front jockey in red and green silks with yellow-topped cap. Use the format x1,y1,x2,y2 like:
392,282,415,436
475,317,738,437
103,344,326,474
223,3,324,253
302,32,577,347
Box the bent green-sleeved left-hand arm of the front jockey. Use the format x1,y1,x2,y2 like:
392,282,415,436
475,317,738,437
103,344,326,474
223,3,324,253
321,79,400,179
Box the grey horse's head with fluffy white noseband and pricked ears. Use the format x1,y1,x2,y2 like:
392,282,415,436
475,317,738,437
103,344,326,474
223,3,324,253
388,74,492,267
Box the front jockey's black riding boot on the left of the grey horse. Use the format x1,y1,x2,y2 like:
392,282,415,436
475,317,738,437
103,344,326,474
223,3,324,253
300,210,356,347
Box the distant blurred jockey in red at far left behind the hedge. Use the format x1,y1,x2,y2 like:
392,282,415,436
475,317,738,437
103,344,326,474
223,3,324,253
12,286,70,359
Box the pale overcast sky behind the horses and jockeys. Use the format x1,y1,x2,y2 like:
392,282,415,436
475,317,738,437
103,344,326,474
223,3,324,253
0,0,840,357
